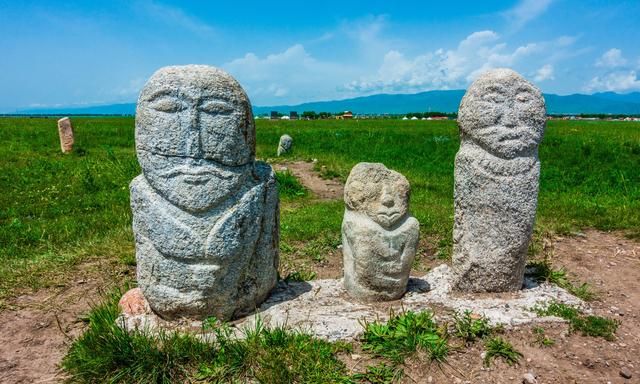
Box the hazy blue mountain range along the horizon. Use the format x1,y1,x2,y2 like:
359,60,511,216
18,90,640,115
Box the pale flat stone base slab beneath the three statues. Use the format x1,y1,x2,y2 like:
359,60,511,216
118,265,589,341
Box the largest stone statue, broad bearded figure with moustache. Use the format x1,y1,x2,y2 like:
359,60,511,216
131,65,278,320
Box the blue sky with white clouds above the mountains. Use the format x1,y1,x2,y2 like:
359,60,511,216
0,0,640,112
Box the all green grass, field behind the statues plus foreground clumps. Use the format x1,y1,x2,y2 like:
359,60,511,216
0,118,640,384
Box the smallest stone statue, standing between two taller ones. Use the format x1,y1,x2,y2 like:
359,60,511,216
342,163,420,301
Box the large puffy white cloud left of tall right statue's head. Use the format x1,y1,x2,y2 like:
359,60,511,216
345,31,567,93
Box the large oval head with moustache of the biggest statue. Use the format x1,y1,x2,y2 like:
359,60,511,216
136,65,255,212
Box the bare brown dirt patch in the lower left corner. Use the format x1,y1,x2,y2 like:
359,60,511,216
0,261,132,383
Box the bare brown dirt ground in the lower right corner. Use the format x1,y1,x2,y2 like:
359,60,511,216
404,230,640,384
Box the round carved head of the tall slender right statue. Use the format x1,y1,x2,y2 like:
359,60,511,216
458,69,546,159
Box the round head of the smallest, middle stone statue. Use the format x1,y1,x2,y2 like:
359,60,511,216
345,163,409,229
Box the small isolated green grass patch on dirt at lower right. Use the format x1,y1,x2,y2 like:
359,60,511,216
534,302,620,341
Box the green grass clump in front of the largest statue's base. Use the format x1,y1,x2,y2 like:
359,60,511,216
62,291,354,383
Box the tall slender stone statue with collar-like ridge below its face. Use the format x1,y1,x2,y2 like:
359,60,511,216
453,69,546,292
